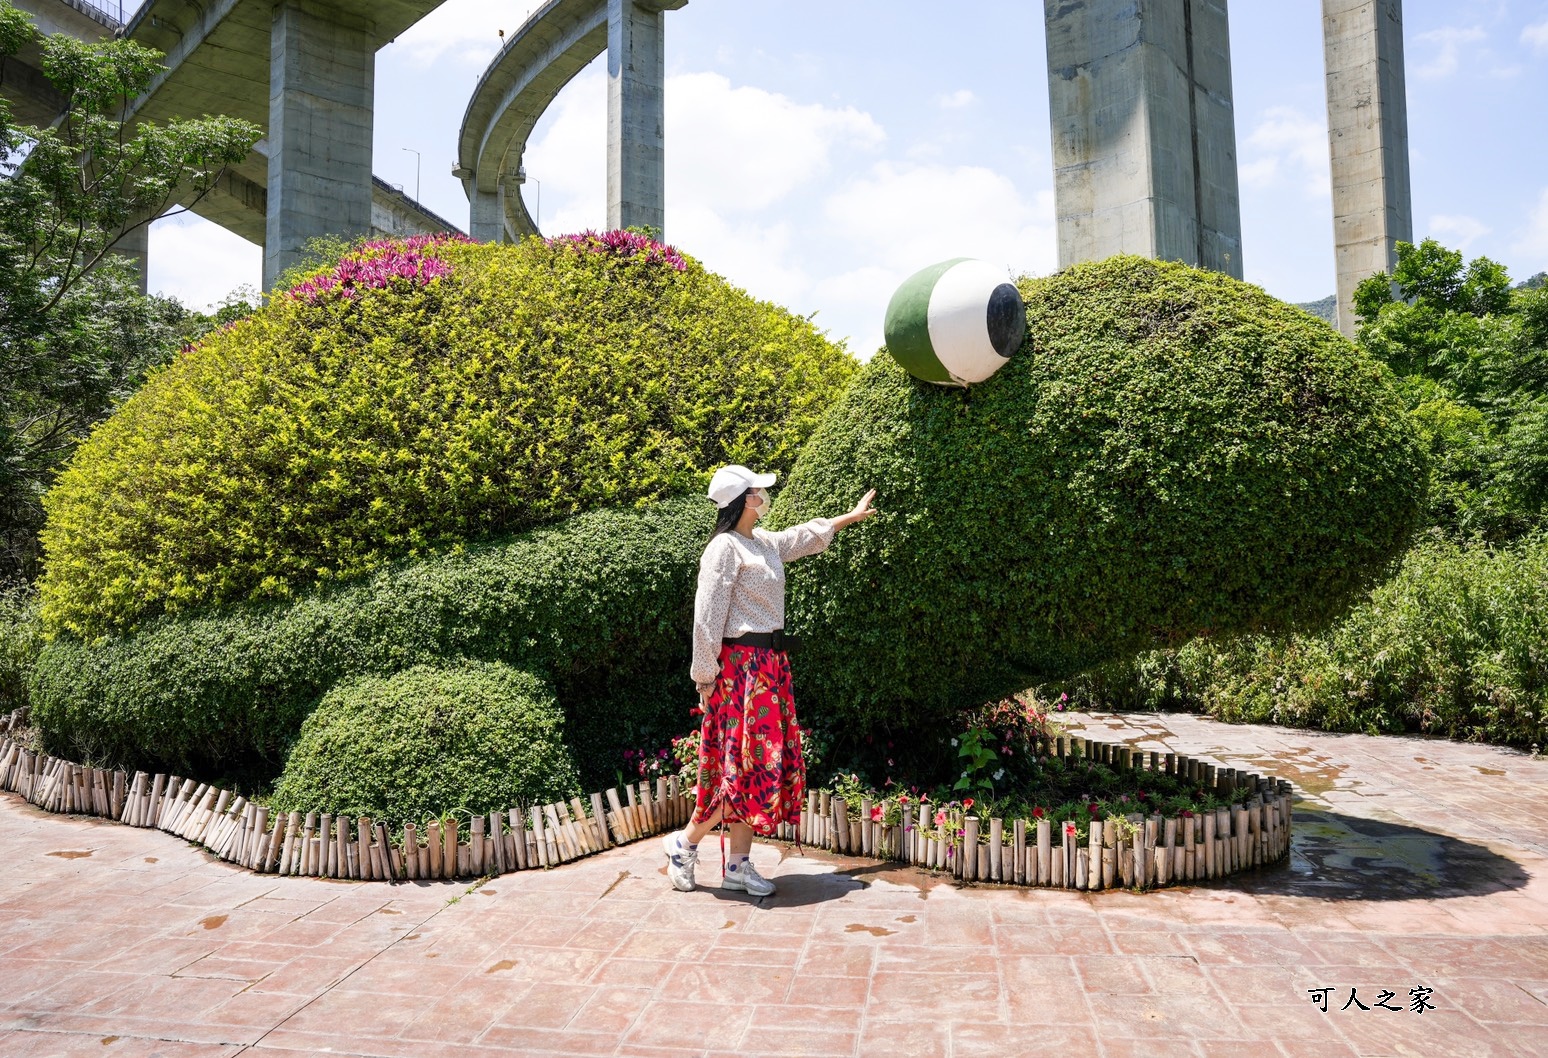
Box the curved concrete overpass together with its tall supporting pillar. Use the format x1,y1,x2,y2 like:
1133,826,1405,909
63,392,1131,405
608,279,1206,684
455,0,687,242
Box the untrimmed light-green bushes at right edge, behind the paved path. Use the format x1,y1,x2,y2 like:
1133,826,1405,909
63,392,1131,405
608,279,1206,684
1068,536,1548,748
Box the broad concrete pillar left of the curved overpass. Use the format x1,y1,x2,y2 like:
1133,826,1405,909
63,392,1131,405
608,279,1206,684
263,0,376,288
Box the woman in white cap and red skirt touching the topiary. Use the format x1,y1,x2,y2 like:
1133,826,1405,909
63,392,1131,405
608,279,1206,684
663,466,876,897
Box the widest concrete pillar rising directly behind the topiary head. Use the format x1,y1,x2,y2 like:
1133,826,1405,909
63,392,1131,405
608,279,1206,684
1043,0,1241,279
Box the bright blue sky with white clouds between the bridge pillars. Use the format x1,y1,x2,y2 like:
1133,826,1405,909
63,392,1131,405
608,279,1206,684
150,0,1548,356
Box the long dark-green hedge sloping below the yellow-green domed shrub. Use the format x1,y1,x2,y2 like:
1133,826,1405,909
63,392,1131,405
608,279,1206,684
31,497,714,782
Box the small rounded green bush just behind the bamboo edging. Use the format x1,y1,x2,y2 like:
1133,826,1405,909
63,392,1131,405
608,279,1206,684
271,661,581,823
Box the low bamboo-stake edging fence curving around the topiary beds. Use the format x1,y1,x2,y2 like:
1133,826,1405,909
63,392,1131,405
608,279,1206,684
0,714,1293,889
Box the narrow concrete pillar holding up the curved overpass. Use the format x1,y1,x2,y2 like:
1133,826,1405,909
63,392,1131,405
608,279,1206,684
607,0,687,232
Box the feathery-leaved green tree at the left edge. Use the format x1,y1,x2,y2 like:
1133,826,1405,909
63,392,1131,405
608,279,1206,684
0,0,262,581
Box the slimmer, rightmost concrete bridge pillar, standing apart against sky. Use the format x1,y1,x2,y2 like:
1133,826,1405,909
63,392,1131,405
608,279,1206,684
1322,0,1413,338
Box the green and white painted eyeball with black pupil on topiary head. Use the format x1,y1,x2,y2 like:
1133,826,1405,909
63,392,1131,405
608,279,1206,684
885,257,1026,386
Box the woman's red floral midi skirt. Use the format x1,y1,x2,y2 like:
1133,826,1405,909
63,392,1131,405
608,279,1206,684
694,644,807,835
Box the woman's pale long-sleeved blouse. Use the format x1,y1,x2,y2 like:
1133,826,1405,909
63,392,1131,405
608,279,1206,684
690,517,834,683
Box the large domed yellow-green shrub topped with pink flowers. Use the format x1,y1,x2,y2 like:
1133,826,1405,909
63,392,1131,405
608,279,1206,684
40,239,854,637
